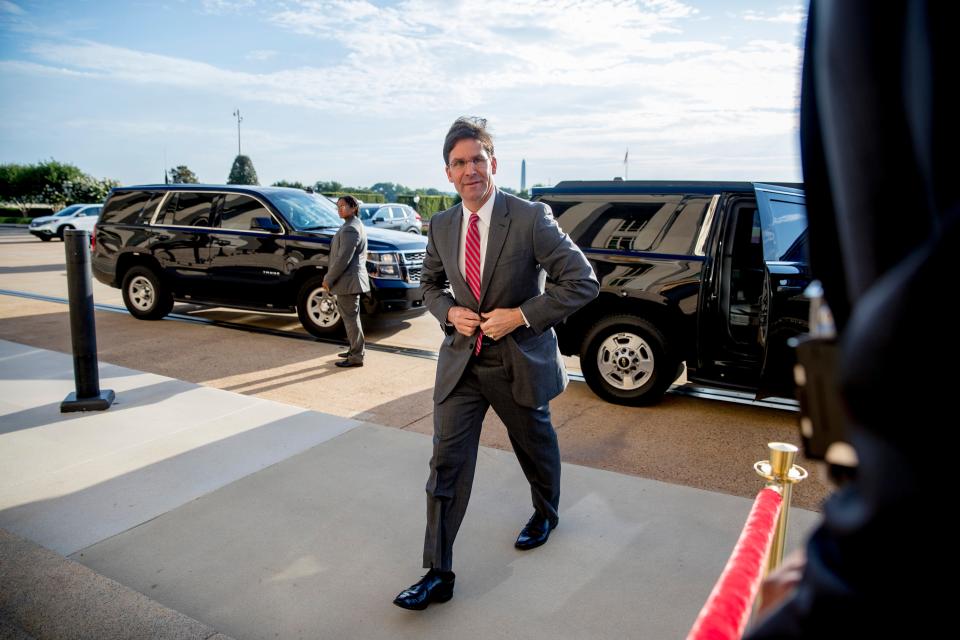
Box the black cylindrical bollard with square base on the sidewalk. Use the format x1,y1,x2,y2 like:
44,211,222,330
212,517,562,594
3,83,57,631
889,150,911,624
60,229,114,413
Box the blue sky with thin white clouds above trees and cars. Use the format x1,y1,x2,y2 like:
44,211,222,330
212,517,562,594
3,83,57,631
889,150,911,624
0,0,804,191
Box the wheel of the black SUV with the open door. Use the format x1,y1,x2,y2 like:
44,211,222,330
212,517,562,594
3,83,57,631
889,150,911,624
580,315,681,406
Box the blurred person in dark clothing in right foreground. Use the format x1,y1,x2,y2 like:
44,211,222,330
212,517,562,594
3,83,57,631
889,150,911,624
747,0,960,640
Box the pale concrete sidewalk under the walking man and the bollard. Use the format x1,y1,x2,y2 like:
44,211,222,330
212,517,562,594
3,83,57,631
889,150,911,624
0,341,817,638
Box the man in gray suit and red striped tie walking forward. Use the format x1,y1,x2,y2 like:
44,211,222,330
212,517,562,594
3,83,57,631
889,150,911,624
394,118,599,610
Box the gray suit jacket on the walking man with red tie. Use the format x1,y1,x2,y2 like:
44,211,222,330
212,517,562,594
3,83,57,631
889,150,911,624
420,191,600,407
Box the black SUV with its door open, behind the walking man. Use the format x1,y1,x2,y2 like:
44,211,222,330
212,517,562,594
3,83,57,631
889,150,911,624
533,181,810,405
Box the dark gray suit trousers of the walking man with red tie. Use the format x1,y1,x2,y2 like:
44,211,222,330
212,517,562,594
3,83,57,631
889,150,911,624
423,343,560,571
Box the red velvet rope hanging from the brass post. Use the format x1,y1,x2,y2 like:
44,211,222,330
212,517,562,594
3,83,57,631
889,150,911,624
687,487,783,640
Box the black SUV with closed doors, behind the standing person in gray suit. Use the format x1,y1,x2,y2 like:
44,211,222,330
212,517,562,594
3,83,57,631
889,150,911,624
92,184,427,336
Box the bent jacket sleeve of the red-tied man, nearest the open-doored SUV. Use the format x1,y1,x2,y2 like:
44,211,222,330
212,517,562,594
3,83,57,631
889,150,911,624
520,203,600,333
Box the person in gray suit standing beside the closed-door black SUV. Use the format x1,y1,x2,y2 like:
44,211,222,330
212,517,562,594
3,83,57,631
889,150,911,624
323,196,370,367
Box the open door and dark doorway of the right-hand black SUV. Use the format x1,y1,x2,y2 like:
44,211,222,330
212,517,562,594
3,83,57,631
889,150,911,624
689,183,810,398
